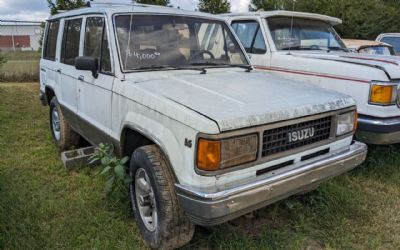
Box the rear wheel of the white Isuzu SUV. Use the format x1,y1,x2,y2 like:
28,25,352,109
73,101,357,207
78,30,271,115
50,97,80,151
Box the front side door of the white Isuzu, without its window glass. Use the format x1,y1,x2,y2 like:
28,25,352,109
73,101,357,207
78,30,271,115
75,15,114,144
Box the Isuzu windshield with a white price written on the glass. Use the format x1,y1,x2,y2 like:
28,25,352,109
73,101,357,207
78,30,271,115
115,14,248,72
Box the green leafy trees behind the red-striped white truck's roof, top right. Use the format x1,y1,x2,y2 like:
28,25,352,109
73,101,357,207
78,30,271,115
251,0,400,40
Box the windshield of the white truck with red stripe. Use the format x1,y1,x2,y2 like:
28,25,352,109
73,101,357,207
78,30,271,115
267,17,346,50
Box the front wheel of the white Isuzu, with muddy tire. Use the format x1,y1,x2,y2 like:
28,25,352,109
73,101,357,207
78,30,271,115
129,145,194,249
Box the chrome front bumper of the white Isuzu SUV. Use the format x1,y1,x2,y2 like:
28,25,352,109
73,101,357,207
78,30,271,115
176,142,367,226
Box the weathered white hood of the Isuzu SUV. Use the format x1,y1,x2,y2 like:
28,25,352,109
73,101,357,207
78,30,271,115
128,69,355,131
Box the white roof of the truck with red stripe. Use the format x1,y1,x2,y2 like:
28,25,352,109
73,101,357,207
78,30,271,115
222,10,342,25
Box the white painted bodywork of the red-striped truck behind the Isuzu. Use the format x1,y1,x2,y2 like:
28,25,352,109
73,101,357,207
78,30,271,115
224,11,400,117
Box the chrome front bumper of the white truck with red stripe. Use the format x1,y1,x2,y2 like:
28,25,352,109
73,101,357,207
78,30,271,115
356,115,400,145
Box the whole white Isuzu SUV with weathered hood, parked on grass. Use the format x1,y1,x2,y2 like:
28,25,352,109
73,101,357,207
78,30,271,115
40,4,367,249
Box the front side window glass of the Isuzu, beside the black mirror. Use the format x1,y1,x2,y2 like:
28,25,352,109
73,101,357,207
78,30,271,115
83,17,111,73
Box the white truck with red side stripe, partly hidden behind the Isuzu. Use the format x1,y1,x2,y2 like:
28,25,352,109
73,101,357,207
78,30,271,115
225,11,400,144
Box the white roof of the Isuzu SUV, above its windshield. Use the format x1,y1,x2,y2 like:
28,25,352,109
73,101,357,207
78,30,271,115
49,3,224,21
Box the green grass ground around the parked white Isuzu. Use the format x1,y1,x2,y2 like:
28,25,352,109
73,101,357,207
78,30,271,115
0,83,400,250
